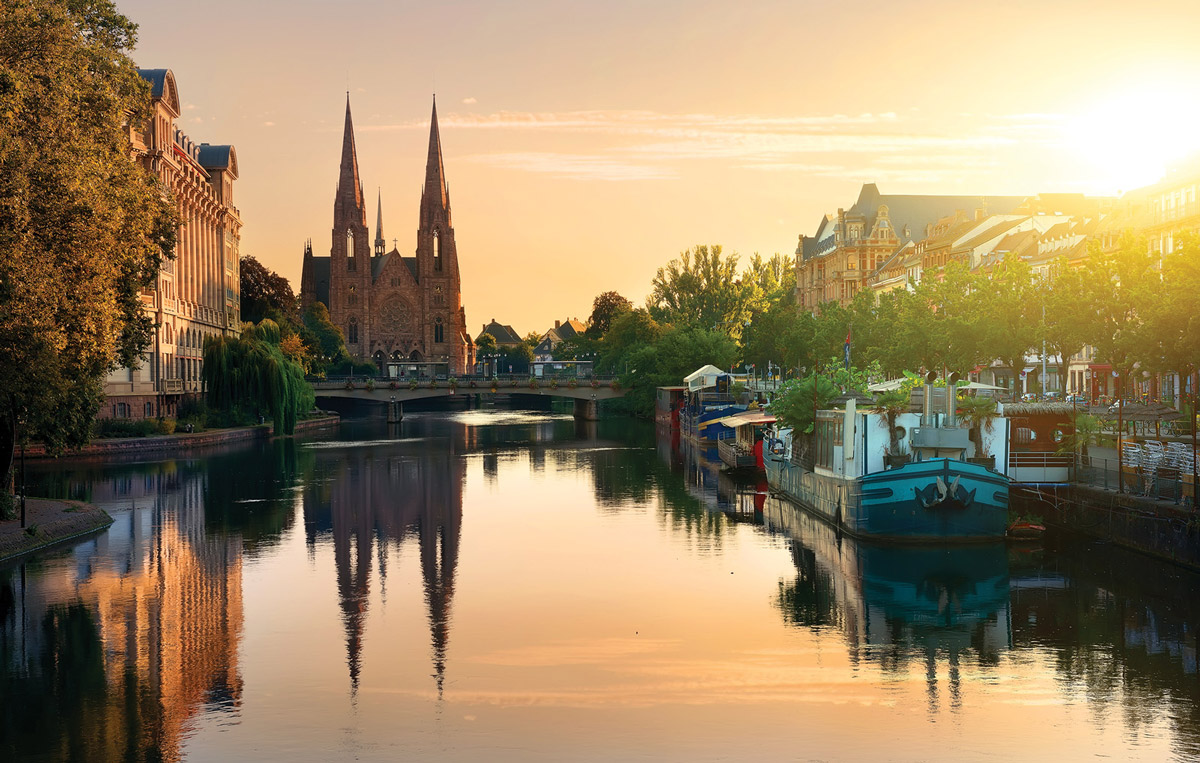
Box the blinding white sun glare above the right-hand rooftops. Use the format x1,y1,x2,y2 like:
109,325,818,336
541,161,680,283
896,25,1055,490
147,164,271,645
1063,83,1200,193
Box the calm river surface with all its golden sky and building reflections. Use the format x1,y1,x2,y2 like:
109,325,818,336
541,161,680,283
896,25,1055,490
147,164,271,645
0,411,1200,762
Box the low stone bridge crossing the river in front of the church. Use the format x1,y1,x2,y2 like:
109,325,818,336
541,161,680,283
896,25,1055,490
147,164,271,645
312,376,628,422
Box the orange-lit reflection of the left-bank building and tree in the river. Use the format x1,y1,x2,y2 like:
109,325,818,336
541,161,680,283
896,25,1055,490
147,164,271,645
0,462,242,761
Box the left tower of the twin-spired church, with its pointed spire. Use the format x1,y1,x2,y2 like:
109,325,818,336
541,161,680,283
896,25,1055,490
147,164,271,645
329,94,371,356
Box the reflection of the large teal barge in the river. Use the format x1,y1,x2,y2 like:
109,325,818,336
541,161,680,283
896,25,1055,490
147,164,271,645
764,498,1013,714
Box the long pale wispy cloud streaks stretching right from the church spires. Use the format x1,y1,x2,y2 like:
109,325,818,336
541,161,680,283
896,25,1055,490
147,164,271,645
361,107,1062,181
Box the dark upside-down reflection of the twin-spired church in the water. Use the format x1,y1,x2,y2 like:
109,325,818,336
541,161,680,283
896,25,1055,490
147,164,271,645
304,421,468,697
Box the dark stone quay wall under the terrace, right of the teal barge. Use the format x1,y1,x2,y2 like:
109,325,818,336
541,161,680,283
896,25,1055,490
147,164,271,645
1013,485,1200,570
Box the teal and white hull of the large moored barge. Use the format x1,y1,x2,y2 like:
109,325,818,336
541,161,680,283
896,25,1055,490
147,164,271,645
766,455,1009,543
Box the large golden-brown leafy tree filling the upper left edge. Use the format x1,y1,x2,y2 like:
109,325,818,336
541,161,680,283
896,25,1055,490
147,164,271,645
0,0,176,513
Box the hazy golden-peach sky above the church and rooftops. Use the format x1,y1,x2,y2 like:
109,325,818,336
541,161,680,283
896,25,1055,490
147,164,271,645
118,0,1200,335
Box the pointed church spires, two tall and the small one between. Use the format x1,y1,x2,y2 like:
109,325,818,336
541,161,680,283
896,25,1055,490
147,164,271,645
334,92,450,247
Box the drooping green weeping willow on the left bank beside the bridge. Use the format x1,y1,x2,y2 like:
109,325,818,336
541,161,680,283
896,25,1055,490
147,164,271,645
204,319,316,434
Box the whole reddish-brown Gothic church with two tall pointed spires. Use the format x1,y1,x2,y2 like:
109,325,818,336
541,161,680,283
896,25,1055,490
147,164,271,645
300,96,475,376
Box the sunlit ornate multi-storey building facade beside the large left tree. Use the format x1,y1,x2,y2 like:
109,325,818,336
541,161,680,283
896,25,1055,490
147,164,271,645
100,68,241,419
